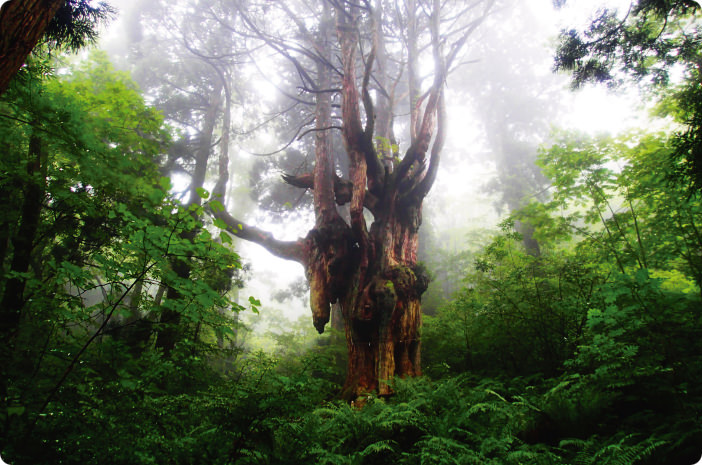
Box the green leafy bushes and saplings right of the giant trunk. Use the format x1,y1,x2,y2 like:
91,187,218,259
423,126,702,463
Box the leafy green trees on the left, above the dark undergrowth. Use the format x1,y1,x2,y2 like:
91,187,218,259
0,51,248,463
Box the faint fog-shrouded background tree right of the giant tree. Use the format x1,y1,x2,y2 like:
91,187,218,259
463,4,561,255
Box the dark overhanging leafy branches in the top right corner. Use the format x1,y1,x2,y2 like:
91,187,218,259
556,0,702,189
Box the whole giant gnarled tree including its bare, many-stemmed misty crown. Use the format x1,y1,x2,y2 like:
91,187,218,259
213,0,494,398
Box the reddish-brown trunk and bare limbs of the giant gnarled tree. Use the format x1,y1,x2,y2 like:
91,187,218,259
216,0,492,399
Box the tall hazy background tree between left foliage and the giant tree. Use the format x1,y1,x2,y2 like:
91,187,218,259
120,1,250,352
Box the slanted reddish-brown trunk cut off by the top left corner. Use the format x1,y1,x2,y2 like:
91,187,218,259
0,0,65,94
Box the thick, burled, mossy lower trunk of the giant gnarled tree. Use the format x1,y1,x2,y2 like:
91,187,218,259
306,199,429,398
